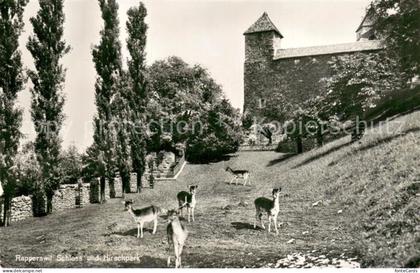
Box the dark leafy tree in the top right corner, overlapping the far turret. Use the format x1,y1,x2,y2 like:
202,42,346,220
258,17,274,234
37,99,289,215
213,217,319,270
370,0,420,78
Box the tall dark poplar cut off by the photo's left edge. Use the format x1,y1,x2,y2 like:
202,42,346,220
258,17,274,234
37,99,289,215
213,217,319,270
0,0,28,225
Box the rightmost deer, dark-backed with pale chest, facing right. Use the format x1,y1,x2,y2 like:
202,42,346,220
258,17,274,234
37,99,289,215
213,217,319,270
254,187,281,234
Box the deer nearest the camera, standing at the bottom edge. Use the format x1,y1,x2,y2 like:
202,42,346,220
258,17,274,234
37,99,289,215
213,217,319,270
166,210,188,268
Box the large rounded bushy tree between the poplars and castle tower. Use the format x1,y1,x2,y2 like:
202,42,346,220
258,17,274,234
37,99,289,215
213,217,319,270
148,57,240,160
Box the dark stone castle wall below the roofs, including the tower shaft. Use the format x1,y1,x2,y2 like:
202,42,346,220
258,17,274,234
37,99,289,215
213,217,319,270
244,38,376,123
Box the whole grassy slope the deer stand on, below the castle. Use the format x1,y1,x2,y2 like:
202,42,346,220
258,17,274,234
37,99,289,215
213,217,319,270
0,112,420,267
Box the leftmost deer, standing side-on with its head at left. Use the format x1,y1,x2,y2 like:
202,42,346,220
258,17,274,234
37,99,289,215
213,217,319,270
125,200,161,238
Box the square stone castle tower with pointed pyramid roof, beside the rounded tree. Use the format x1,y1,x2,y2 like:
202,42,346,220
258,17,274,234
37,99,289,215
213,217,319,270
244,12,283,116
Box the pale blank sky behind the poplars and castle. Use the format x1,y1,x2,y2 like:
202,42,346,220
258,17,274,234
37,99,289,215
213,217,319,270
18,0,370,151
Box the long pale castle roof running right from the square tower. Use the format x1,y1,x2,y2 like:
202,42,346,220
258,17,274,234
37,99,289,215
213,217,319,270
274,40,383,60
